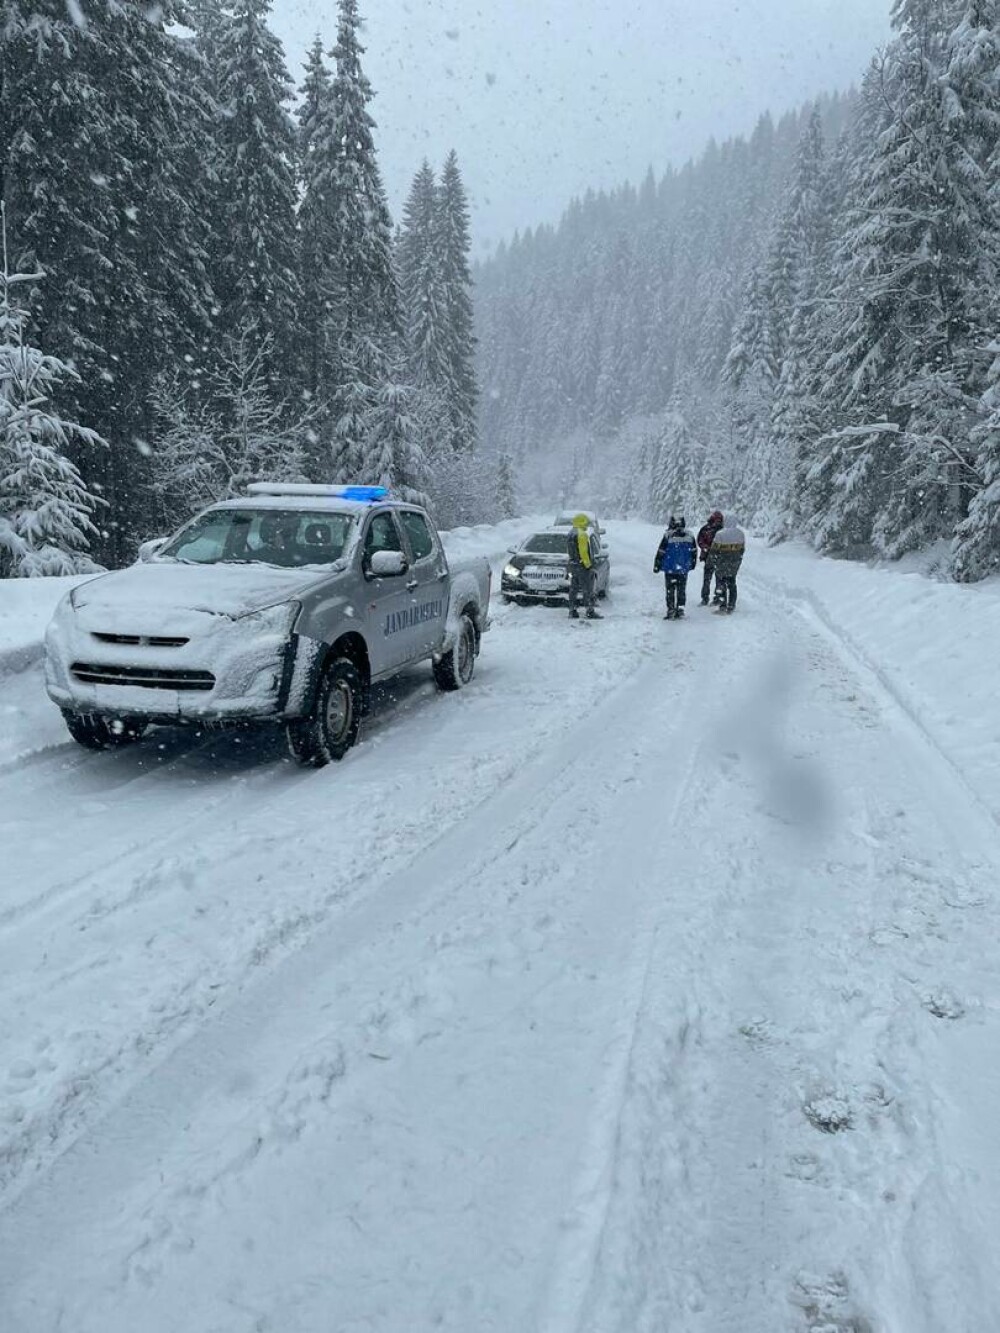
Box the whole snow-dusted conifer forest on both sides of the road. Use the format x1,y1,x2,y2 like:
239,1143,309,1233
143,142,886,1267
0,0,1000,581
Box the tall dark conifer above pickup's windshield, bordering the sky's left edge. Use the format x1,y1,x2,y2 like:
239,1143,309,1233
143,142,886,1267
213,0,300,387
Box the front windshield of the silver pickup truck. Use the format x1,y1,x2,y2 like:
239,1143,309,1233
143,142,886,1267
160,509,355,569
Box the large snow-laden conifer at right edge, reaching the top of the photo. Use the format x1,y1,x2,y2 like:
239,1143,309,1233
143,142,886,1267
827,0,996,556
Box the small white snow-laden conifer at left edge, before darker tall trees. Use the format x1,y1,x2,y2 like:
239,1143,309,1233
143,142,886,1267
0,212,107,579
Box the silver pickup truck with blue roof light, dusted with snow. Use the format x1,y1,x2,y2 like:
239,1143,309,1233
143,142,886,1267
45,483,492,766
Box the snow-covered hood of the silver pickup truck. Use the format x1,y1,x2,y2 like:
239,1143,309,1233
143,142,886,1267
73,561,328,635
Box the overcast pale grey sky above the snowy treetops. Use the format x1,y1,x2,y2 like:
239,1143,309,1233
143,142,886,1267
273,0,889,253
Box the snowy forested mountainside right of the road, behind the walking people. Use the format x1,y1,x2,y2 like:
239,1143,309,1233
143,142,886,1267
477,0,1000,579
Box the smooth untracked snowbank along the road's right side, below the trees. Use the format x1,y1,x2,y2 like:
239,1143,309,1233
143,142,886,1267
744,543,1000,820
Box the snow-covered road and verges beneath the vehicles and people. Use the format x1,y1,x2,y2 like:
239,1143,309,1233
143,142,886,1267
0,524,1000,1333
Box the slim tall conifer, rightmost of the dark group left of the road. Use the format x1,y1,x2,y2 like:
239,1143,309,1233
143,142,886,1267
436,149,477,452
